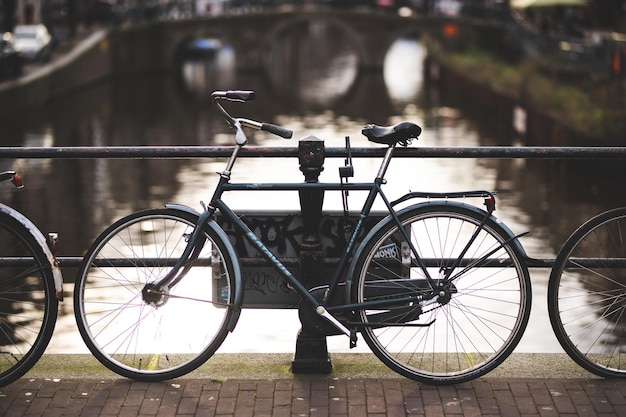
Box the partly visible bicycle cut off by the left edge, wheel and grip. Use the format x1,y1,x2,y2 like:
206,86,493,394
0,171,63,386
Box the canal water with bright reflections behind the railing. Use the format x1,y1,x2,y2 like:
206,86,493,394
0,36,620,353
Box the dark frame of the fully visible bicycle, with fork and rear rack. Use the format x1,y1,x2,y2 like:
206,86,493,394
155,141,502,337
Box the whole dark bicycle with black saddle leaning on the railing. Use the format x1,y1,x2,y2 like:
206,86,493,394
74,91,531,384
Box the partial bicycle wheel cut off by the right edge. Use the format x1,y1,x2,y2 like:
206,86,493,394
548,208,626,378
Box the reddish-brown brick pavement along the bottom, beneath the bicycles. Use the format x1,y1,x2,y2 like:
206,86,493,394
0,375,626,417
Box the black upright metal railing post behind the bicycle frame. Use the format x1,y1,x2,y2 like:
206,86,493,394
291,136,332,373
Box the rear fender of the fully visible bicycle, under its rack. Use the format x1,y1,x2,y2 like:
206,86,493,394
346,200,528,296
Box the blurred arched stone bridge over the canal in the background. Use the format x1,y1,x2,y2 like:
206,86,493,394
163,10,446,70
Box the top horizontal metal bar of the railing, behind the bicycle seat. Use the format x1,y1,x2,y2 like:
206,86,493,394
0,146,626,159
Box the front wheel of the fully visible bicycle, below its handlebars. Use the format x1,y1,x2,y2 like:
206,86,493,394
74,209,236,381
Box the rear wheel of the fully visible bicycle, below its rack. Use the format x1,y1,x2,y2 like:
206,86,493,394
353,202,532,384
